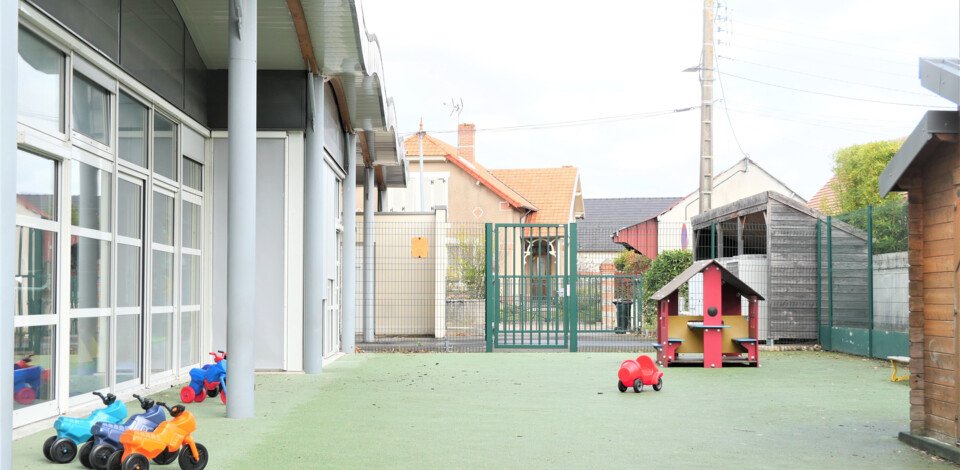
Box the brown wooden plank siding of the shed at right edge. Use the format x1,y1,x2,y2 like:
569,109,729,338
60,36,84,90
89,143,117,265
901,145,960,444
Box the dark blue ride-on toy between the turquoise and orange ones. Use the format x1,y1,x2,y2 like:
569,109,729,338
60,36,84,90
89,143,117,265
80,395,167,470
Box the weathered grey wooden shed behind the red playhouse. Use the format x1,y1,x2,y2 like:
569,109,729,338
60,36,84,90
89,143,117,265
692,191,869,342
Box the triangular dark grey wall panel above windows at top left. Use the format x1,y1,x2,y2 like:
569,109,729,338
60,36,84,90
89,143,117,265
30,0,120,62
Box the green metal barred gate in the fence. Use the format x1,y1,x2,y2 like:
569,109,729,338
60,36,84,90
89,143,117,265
485,224,577,351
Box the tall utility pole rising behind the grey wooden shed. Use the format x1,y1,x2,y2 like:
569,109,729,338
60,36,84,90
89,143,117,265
700,0,714,214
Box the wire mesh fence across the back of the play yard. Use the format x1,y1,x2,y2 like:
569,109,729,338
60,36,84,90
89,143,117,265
356,199,908,355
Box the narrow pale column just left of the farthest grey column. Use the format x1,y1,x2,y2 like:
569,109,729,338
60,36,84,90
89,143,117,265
340,132,357,354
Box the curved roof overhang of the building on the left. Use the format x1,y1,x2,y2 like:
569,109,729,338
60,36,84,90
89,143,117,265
174,0,406,176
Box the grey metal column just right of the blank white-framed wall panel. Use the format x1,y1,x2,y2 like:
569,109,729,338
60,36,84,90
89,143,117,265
303,75,332,374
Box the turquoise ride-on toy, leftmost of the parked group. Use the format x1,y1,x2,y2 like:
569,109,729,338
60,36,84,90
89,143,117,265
43,392,127,463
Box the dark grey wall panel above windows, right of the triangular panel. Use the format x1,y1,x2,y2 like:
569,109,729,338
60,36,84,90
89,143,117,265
120,0,186,108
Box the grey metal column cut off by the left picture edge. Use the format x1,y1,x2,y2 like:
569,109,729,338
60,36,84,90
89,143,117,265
0,2,20,470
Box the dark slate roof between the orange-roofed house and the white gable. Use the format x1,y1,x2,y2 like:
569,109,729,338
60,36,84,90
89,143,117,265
577,197,681,251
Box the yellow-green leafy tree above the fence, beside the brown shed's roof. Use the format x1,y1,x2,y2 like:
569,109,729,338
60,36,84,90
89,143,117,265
831,140,903,212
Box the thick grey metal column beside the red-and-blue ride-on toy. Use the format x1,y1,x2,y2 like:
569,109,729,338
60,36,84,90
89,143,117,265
227,0,257,419
